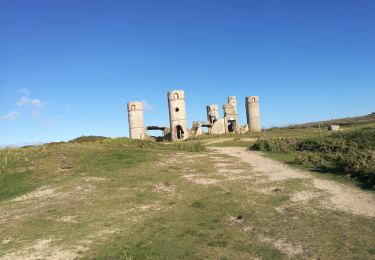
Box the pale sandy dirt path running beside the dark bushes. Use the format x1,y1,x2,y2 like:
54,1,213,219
212,147,375,217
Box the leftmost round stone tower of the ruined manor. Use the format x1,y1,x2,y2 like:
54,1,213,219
128,101,146,139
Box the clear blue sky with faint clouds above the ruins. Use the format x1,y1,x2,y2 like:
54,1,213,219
0,0,375,145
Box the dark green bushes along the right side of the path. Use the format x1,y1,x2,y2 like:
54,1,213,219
250,128,375,187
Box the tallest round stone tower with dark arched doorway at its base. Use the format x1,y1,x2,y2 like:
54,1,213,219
168,90,188,141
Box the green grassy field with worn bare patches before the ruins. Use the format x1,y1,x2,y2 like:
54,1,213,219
0,116,375,259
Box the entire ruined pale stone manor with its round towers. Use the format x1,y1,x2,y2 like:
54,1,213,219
128,90,261,141
